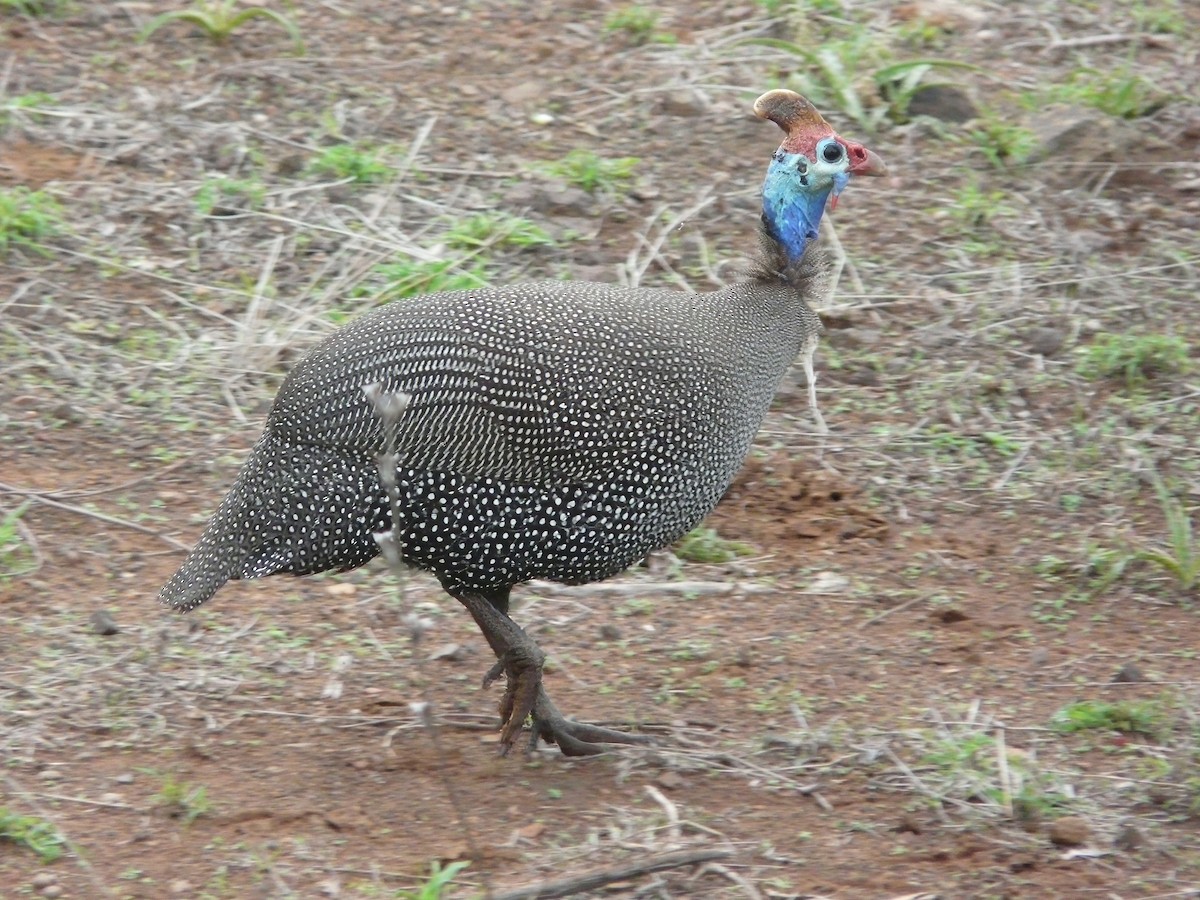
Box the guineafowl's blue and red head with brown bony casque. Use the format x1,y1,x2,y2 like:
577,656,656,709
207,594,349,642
754,90,887,262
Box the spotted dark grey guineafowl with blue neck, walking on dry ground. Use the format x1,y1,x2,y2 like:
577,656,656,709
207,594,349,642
160,89,886,756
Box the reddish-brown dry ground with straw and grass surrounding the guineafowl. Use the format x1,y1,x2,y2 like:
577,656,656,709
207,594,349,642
0,0,1200,899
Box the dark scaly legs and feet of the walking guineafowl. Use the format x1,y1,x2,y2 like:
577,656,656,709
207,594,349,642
455,592,648,756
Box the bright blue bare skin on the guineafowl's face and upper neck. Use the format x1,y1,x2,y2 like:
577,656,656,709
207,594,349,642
762,148,850,263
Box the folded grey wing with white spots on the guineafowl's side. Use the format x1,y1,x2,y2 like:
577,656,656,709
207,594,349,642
262,286,696,487
